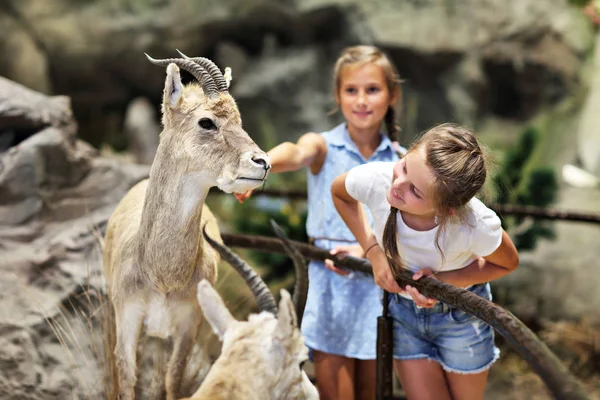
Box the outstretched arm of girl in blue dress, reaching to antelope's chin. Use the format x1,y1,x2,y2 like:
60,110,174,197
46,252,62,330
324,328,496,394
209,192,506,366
234,133,327,203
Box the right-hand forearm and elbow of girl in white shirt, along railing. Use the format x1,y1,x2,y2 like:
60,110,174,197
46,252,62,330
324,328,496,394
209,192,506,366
436,230,519,287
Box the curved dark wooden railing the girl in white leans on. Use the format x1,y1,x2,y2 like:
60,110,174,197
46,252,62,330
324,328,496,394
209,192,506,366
221,234,588,400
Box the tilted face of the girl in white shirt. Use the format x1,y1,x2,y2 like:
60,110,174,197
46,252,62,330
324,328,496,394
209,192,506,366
386,146,435,217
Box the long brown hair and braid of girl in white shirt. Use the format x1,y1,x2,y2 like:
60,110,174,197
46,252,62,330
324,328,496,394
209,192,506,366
383,124,487,278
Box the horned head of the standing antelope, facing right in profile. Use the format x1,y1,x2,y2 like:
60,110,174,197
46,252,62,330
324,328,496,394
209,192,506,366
146,54,271,193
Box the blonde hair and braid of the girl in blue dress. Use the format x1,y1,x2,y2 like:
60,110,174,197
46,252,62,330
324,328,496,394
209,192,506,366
333,45,402,141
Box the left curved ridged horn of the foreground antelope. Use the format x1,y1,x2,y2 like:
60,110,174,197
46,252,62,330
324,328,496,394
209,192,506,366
202,225,277,316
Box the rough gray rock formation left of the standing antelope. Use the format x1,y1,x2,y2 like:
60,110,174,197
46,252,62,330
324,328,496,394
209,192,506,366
0,80,148,400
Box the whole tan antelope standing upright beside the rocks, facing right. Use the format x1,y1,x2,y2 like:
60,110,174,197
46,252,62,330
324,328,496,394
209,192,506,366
103,54,270,400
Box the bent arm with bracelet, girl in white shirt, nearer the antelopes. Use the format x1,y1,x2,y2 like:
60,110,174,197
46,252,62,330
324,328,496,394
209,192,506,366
331,173,402,293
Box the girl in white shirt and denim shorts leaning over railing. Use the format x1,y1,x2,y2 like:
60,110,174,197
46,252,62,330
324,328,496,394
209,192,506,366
331,124,518,400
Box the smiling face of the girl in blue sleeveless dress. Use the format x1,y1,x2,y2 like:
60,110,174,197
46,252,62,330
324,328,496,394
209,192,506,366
336,63,398,134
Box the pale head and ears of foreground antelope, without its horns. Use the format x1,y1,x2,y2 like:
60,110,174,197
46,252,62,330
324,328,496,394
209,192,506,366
198,280,319,400
